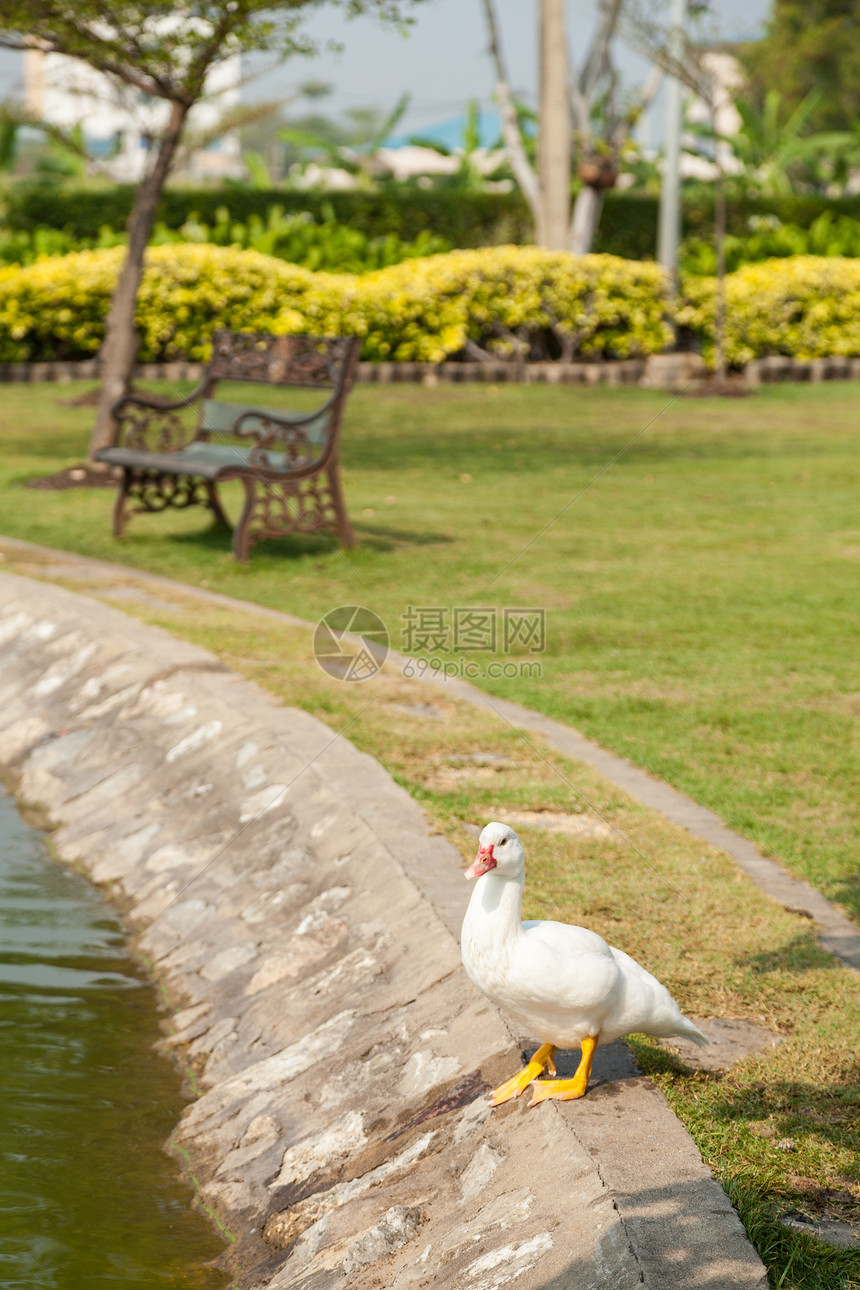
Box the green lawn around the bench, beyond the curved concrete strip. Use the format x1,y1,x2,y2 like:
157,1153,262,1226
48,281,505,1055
0,384,860,917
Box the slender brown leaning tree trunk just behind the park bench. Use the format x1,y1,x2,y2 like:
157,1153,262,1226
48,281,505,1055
89,103,188,461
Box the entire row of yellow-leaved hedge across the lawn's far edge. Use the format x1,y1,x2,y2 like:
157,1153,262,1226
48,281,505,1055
6,244,860,365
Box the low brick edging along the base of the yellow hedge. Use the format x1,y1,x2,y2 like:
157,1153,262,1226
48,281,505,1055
0,352,860,390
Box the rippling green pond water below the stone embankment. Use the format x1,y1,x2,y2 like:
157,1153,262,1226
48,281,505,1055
0,791,227,1290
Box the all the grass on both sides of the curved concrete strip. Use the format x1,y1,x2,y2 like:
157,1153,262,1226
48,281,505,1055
0,376,860,1290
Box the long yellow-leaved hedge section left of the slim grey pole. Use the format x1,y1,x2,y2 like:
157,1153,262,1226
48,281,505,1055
0,245,670,362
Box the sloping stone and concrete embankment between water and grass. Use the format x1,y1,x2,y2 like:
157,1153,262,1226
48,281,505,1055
0,574,767,1290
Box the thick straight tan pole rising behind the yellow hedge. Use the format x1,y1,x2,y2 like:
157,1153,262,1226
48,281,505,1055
535,0,570,250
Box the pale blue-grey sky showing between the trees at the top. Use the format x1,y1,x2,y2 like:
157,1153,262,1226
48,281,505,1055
0,0,768,132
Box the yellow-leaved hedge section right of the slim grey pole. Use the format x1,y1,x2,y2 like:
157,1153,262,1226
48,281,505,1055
676,255,860,366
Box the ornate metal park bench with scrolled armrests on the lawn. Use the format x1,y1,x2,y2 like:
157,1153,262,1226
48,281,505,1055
95,330,361,564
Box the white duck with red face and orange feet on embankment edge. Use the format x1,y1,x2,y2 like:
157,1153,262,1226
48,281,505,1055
462,823,708,1107
